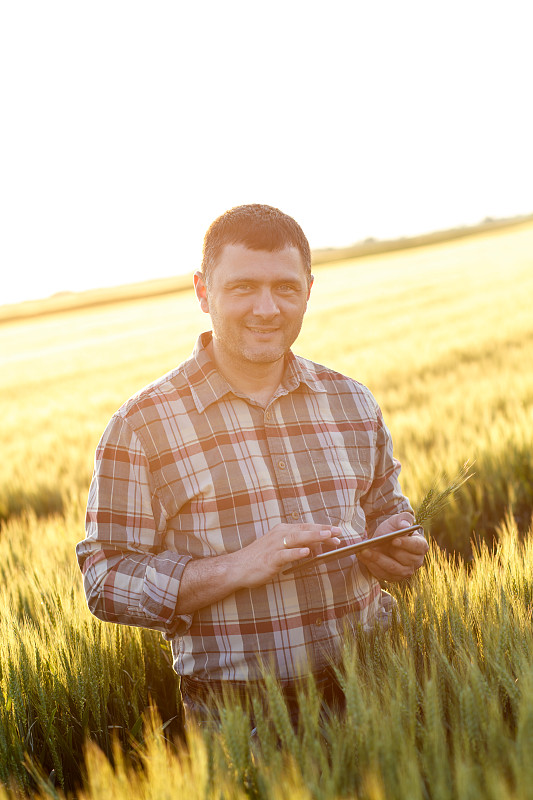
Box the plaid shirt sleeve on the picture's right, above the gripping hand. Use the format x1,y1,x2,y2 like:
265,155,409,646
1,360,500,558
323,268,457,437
361,404,413,537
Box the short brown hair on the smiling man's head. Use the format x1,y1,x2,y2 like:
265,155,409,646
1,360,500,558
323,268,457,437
202,203,311,286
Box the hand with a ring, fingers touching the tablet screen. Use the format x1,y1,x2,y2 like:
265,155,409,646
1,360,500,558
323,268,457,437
231,523,341,589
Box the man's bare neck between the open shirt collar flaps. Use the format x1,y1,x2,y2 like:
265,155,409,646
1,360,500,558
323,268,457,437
207,340,285,406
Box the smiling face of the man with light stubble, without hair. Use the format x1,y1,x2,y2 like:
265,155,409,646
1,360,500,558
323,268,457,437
195,244,311,369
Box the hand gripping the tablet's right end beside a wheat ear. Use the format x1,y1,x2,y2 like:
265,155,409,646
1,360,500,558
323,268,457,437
357,511,429,581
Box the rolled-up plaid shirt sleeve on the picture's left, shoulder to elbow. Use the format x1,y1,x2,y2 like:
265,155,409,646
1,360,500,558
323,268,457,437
76,415,192,638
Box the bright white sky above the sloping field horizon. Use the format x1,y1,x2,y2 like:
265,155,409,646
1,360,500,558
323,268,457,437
0,0,533,305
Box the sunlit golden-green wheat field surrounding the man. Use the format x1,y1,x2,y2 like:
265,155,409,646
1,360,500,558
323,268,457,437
0,223,533,800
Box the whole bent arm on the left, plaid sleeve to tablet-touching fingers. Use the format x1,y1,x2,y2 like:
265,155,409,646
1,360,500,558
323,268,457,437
76,417,340,635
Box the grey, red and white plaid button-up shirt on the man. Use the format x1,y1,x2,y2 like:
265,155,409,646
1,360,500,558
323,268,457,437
77,333,411,680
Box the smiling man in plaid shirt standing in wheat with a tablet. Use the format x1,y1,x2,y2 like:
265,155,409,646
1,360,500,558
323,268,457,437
77,205,427,720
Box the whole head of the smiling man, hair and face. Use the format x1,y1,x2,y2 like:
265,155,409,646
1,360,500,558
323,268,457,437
194,205,313,375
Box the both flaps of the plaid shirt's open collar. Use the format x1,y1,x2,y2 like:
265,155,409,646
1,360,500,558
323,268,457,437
183,331,327,414
